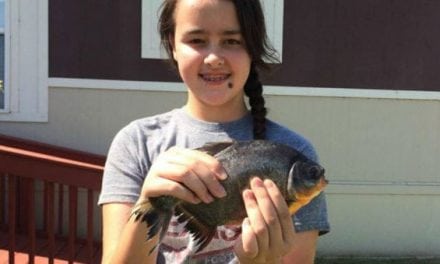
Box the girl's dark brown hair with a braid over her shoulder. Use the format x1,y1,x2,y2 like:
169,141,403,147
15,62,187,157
159,0,277,139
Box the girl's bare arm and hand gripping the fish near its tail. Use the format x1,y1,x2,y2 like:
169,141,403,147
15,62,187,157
102,147,227,264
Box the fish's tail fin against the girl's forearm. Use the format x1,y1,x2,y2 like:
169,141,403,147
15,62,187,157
131,200,173,254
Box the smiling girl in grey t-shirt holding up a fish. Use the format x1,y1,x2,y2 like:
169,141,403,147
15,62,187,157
99,0,329,264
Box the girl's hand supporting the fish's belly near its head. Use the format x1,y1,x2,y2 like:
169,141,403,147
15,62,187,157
234,178,295,263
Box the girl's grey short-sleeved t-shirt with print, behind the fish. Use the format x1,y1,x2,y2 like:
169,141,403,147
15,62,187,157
98,108,330,263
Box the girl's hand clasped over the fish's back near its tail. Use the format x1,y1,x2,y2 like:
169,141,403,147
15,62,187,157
140,147,227,203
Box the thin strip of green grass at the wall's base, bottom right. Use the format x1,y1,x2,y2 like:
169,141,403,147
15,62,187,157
315,257,440,264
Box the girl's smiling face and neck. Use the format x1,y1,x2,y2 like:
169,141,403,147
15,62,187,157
173,0,251,121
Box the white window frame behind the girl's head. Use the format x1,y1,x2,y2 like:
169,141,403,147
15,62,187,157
142,0,284,62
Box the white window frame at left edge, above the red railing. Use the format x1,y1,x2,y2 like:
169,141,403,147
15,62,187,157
0,0,48,122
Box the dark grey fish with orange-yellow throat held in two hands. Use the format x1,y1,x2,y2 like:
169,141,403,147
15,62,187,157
132,140,328,253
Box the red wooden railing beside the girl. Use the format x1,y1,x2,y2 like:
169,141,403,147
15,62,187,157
0,135,105,263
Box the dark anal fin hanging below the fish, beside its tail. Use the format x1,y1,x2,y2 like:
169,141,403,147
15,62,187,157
176,206,217,253
